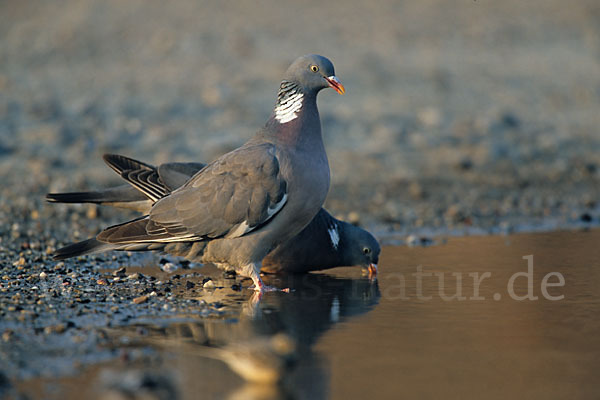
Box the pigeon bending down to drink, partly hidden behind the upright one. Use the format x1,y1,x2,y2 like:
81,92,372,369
46,154,380,275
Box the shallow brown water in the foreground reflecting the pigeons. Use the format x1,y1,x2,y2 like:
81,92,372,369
9,230,600,399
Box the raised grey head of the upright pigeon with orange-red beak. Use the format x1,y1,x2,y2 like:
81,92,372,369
284,54,346,94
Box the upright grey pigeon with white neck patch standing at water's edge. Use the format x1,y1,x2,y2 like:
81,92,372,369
55,55,345,292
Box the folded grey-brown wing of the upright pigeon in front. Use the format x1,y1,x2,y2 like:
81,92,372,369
98,144,287,243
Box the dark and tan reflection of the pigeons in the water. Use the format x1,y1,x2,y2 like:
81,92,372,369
106,274,380,399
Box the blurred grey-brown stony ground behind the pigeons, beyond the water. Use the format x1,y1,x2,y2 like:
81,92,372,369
0,0,600,239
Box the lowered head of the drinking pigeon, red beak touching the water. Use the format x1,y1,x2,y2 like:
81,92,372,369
344,224,381,276
